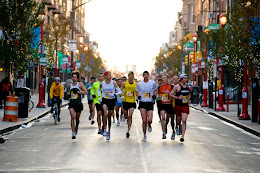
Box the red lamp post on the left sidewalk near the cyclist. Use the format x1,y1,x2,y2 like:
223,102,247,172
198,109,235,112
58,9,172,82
36,13,46,108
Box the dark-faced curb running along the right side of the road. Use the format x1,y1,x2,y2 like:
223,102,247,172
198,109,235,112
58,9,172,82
190,106,260,137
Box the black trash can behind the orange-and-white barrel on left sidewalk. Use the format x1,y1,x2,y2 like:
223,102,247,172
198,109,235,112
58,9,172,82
14,87,30,118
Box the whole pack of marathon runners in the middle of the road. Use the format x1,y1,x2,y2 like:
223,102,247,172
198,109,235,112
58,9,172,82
65,71,191,142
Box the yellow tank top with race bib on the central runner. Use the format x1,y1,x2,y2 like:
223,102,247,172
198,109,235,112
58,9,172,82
124,81,136,103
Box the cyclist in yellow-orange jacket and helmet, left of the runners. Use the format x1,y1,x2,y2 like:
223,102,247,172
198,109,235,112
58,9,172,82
50,77,64,122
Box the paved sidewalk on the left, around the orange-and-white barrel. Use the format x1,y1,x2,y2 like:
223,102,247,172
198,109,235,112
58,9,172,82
0,93,68,135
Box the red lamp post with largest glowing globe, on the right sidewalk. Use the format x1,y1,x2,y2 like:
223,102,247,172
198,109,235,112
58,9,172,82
217,13,227,111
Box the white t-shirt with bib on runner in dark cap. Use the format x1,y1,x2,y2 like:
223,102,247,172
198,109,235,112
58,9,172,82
136,80,157,102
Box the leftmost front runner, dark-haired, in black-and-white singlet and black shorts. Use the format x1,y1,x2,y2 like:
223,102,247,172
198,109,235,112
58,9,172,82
68,71,87,139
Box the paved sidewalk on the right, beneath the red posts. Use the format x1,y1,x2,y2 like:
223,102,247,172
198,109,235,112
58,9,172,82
190,104,260,137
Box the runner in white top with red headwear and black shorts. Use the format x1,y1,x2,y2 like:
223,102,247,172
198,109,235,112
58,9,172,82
98,71,122,140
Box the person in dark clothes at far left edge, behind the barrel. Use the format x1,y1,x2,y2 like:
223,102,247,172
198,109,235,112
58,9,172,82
0,77,13,109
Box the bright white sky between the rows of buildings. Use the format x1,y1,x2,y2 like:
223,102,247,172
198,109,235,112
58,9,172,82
85,0,182,73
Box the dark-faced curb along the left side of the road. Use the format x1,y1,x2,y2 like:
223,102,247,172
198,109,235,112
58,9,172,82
0,103,69,135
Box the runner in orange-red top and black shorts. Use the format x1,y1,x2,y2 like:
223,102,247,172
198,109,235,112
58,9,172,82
157,74,175,140
